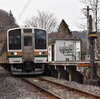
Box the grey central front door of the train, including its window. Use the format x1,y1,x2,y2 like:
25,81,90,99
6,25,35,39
22,33,34,61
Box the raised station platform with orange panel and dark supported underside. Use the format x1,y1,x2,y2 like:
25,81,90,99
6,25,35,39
48,61,100,83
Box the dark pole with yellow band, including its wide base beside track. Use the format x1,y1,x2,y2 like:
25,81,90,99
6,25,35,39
87,6,99,85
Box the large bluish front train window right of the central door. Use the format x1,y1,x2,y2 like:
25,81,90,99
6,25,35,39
35,29,46,49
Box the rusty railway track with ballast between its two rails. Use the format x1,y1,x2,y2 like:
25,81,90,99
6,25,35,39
21,77,100,99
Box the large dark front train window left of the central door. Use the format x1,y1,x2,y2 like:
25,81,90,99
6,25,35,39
9,29,21,50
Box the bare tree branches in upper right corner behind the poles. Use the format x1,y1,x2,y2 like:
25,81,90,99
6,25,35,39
79,0,100,31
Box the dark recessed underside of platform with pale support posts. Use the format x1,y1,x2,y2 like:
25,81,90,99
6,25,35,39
49,65,83,83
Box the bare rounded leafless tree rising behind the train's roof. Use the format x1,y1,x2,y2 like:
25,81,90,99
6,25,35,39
25,11,57,32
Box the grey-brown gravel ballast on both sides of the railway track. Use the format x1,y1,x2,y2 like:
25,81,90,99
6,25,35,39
0,68,100,99
